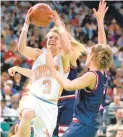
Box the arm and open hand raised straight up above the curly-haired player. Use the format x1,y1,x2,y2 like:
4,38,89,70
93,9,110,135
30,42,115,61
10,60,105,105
93,0,108,44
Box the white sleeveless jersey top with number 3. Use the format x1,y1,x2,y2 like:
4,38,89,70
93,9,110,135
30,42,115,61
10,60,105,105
29,49,68,100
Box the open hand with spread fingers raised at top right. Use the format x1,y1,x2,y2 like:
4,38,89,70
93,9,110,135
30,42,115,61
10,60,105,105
93,0,108,21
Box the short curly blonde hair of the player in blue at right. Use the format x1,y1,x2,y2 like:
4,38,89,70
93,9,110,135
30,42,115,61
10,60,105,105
92,44,113,69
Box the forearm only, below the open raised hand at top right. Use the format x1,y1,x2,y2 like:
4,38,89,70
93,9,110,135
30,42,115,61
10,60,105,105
97,20,106,44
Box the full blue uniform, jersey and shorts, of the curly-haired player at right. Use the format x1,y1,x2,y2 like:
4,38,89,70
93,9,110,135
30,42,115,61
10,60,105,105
63,71,107,137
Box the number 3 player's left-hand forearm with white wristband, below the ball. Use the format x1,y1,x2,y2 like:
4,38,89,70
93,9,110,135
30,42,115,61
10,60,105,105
18,24,29,54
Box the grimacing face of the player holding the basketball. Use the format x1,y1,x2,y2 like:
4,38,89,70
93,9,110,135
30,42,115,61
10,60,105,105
47,32,61,49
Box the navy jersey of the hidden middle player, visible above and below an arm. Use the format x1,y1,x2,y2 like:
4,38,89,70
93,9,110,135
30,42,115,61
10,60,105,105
61,67,78,96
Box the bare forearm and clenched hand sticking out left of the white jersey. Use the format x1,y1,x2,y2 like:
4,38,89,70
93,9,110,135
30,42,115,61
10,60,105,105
8,66,32,79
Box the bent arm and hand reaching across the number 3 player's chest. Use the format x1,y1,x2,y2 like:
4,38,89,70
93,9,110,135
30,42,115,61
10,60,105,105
46,49,96,91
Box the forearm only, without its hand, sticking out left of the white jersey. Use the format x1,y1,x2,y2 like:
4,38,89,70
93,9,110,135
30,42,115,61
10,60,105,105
15,66,32,78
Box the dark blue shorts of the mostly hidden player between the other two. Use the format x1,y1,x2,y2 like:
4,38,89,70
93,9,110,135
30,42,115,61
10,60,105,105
53,98,75,135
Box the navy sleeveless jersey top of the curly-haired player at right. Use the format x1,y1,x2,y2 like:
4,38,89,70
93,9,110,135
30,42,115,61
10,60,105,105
74,71,107,128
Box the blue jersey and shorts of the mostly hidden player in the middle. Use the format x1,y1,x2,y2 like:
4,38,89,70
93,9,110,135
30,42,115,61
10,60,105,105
53,67,77,136
